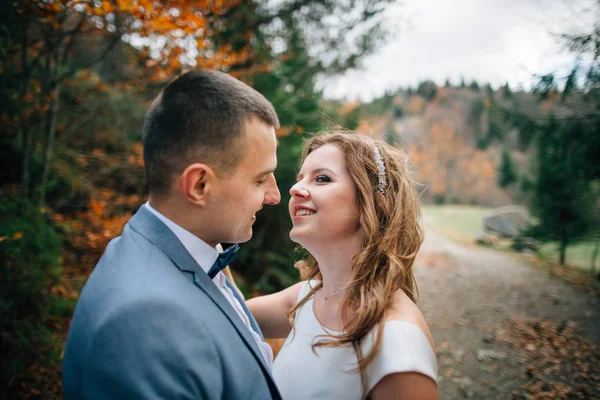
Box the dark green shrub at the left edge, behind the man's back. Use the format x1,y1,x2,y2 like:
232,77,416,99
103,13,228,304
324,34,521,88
0,192,60,397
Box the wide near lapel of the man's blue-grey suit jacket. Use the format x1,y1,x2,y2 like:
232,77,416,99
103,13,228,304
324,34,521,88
129,206,274,388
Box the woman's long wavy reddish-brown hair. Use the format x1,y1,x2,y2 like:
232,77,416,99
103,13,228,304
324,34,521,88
288,132,423,396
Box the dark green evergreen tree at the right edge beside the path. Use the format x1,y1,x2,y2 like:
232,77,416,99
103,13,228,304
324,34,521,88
516,2,600,268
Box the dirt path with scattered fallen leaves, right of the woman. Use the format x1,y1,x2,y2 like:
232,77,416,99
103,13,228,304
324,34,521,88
416,230,600,399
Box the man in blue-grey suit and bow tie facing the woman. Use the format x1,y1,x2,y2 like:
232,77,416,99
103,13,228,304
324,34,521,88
63,70,280,400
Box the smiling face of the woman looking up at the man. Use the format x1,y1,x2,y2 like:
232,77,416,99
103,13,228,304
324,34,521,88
289,144,359,250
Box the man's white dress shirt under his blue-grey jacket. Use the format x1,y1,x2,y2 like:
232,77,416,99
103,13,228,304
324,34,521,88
144,202,273,366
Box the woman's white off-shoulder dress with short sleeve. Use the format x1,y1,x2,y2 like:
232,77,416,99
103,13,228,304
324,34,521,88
273,281,437,400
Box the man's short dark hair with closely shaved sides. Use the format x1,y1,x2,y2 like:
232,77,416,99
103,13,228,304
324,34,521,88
142,70,279,195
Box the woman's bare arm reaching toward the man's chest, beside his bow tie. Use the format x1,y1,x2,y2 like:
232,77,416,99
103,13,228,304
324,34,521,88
246,282,305,339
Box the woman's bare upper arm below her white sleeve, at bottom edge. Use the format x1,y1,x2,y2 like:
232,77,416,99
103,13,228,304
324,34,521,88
368,372,439,400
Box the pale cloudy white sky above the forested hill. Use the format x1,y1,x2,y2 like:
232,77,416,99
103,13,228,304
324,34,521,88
317,0,597,101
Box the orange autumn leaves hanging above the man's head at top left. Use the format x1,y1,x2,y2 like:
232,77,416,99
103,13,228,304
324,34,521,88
19,0,254,81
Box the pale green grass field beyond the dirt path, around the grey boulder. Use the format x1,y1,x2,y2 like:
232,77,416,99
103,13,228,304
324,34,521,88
422,205,600,270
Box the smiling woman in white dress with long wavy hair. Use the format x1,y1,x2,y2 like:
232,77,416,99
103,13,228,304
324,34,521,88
247,133,438,400
